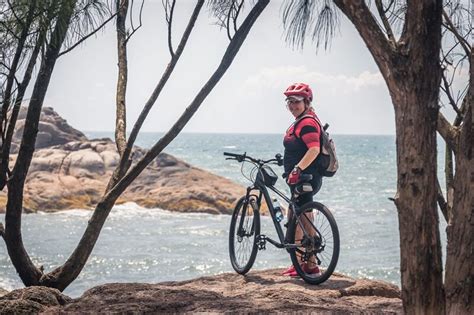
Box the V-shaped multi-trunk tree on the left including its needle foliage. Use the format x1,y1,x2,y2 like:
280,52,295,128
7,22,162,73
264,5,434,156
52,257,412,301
0,0,269,291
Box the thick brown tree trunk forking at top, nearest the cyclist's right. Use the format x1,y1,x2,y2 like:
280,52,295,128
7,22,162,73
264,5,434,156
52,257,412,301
334,0,444,314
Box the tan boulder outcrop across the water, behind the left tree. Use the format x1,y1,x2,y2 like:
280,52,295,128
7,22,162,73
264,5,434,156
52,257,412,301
0,108,245,213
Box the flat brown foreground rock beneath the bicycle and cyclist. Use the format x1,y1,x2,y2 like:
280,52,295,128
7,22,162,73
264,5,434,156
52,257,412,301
0,269,403,314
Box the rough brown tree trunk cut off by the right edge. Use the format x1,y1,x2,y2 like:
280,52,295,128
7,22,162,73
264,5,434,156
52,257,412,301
445,50,474,314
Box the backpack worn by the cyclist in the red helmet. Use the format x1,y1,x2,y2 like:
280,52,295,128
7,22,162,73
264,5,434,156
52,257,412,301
293,115,339,177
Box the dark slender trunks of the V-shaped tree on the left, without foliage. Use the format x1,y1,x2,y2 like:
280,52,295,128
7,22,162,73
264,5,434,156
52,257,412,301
2,0,269,290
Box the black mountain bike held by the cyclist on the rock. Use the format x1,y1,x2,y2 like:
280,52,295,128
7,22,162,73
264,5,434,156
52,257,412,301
224,152,340,284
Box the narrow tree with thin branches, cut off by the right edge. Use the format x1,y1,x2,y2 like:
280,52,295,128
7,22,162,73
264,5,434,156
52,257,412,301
438,1,474,314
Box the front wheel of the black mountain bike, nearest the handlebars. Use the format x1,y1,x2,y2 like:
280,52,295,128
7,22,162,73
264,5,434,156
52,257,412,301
229,195,260,275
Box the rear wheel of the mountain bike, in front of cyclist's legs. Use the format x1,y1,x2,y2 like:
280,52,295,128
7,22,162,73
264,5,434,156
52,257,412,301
288,202,340,284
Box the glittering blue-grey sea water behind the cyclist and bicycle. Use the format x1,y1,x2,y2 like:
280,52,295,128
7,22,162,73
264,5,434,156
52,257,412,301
0,132,444,297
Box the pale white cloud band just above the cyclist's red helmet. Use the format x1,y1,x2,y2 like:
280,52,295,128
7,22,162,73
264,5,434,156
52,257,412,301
244,66,385,92
